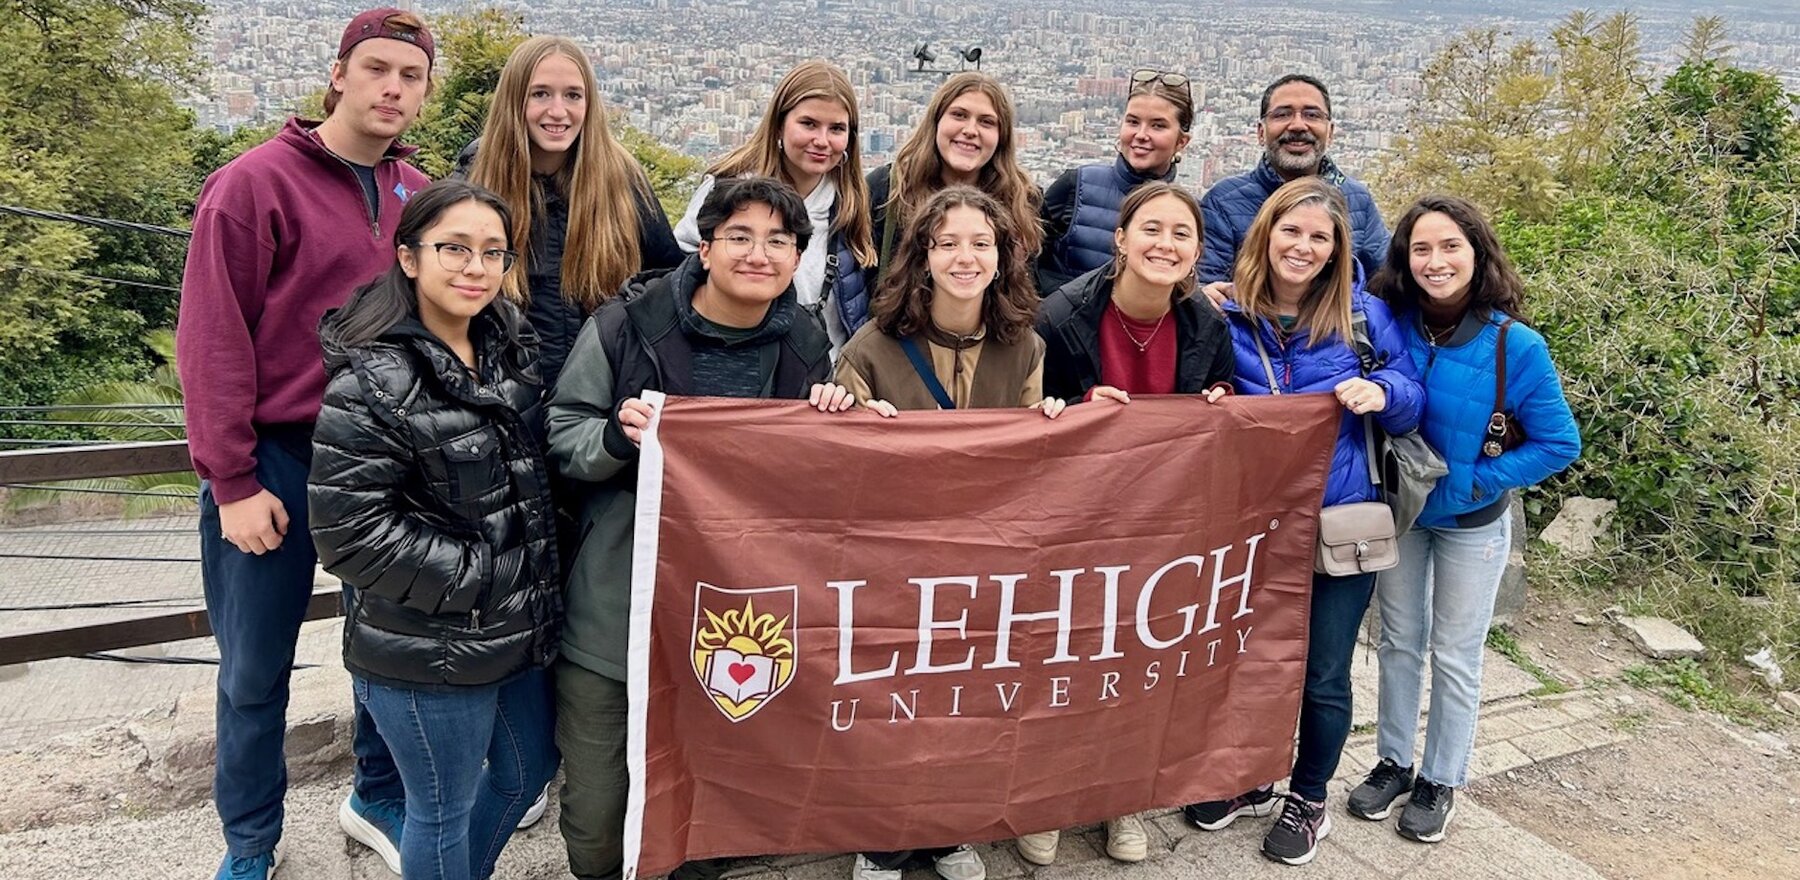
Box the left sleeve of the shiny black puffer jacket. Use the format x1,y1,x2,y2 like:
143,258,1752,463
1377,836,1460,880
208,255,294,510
306,371,493,614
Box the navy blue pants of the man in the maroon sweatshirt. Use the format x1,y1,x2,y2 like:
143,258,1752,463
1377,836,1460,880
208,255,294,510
200,434,403,857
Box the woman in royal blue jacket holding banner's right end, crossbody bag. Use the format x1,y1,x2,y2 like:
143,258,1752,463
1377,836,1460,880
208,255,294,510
1183,178,1424,864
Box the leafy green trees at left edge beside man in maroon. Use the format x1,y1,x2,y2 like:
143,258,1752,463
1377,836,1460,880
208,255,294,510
0,0,205,403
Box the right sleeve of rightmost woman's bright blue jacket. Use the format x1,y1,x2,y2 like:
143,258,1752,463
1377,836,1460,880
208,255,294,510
1474,324,1580,498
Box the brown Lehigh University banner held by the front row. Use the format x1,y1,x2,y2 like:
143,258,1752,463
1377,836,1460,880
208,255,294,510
625,394,1341,878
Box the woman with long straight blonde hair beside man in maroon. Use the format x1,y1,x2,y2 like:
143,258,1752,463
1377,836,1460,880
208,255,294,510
459,36,682,387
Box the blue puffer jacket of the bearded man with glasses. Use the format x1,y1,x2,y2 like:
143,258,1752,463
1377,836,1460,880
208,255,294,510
1201,158,1388,284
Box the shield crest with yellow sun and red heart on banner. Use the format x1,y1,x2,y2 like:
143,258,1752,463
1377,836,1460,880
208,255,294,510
693,581,799,722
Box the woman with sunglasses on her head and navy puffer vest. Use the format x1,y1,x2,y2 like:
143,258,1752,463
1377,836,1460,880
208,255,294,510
1037,68,1193,297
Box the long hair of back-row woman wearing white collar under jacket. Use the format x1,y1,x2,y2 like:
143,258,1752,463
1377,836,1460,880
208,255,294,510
706,59,875,266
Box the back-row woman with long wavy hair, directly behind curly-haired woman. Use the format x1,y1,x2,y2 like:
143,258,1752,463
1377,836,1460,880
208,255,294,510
869,70,1044,288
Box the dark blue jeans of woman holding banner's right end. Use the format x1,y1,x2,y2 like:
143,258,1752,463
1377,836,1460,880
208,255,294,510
1287,574,1375,801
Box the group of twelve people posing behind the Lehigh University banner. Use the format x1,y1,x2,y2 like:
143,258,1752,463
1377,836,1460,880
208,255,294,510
178,9,1580,880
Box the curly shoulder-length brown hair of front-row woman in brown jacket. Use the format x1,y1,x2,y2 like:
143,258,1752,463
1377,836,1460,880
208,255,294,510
869,185,1037,346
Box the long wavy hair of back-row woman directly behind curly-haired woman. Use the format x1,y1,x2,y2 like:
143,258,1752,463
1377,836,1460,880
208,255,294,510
884,70,1044,253
